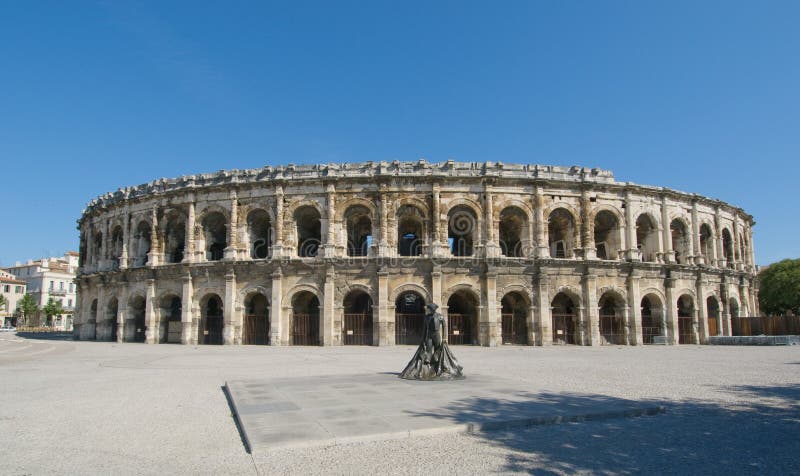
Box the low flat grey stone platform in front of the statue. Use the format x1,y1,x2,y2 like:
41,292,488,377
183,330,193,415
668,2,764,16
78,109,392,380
226,373,664,451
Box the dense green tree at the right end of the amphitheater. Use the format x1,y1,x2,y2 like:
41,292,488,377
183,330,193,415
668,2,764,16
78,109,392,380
758,259,800,316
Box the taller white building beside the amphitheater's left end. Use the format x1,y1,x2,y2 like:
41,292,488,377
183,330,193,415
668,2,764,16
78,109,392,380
6,251,78,331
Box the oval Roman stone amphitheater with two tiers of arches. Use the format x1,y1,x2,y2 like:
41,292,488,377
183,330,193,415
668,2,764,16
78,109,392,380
75,160,758,346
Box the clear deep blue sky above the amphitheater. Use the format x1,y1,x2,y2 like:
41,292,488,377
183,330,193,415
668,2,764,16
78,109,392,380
0,1,800,265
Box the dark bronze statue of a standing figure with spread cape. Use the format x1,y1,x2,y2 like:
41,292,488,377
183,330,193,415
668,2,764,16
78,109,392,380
400,303,464,380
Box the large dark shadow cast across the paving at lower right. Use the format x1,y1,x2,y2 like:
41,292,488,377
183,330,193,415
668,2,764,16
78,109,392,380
410,386,800,475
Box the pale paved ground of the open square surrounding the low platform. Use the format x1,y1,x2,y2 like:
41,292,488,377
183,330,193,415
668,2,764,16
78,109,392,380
0,335,800,474
